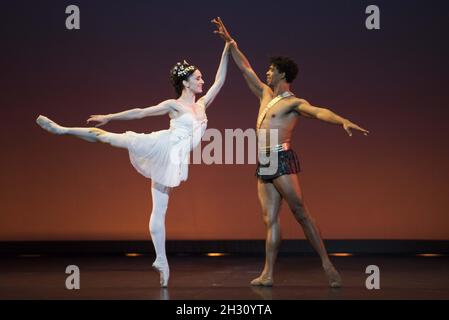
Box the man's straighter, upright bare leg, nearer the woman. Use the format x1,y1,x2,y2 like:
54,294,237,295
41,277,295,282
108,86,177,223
251,179,282,286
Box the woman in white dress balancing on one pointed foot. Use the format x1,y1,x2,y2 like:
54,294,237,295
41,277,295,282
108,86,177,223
36,43,230,287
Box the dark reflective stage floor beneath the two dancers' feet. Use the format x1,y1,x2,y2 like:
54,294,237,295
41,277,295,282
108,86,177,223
0,255,449,300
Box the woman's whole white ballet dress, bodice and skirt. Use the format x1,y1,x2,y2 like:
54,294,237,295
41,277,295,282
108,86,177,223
125,112,207,187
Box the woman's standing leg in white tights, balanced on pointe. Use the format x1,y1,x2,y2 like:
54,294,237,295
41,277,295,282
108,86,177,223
150,182,171,287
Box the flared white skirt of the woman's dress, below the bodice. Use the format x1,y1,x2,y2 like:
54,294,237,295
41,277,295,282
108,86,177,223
124,129,190,187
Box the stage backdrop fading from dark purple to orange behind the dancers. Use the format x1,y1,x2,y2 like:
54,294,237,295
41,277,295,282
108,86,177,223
0,0,449,241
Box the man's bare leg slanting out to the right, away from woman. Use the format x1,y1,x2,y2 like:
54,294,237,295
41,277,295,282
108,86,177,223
273,174,342,288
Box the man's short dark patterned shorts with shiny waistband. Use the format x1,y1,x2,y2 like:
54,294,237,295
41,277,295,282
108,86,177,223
256,149,301,182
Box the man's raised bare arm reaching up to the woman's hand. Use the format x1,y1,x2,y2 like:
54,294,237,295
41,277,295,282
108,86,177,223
212,17,269,99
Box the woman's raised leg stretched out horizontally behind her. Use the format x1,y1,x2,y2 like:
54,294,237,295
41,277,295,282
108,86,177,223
36,116,128,149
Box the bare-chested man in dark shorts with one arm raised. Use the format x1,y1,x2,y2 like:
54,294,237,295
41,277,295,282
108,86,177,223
212,18,369,288
